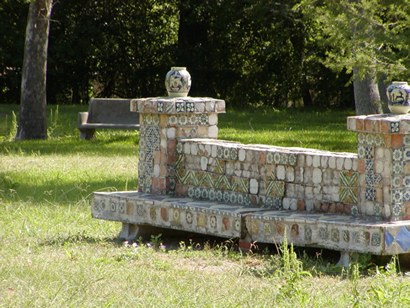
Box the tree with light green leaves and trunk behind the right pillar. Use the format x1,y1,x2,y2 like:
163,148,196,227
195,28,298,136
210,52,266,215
297,0,409,114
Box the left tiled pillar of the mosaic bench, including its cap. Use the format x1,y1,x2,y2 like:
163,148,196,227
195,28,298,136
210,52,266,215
131,97,225,194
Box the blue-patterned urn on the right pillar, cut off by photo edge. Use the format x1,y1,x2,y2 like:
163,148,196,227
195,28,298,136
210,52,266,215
387,81,410,114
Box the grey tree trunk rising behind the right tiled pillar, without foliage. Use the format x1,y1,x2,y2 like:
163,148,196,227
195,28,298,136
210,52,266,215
353,69,383,115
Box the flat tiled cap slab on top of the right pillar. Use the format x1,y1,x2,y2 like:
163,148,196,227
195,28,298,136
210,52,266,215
347,114,410,135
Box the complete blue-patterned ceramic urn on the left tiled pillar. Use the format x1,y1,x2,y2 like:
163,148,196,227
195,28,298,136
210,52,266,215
165,67,191,97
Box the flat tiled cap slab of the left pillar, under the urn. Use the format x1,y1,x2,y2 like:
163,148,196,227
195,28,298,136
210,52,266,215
131,97,225,114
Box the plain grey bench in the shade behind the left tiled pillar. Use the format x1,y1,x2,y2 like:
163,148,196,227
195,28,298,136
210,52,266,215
78,98,140,140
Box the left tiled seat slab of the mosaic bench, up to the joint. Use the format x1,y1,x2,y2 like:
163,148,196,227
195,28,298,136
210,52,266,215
91,192,260,238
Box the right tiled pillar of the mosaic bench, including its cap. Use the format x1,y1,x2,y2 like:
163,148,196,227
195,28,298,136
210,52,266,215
347,114,410,221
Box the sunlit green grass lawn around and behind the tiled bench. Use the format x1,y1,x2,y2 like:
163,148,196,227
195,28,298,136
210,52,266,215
0,105,410,307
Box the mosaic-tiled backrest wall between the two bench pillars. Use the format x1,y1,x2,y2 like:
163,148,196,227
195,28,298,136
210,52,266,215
176,139,359,215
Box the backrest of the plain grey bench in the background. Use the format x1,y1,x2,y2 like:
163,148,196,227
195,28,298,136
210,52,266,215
87,98,139,124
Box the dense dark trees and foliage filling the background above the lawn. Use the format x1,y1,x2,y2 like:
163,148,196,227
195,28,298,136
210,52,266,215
0,0,410,107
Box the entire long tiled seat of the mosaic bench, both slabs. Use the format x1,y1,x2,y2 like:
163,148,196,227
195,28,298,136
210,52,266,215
92,191,410,258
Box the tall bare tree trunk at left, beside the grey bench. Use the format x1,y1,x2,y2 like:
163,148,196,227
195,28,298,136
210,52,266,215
16,0,53,140
